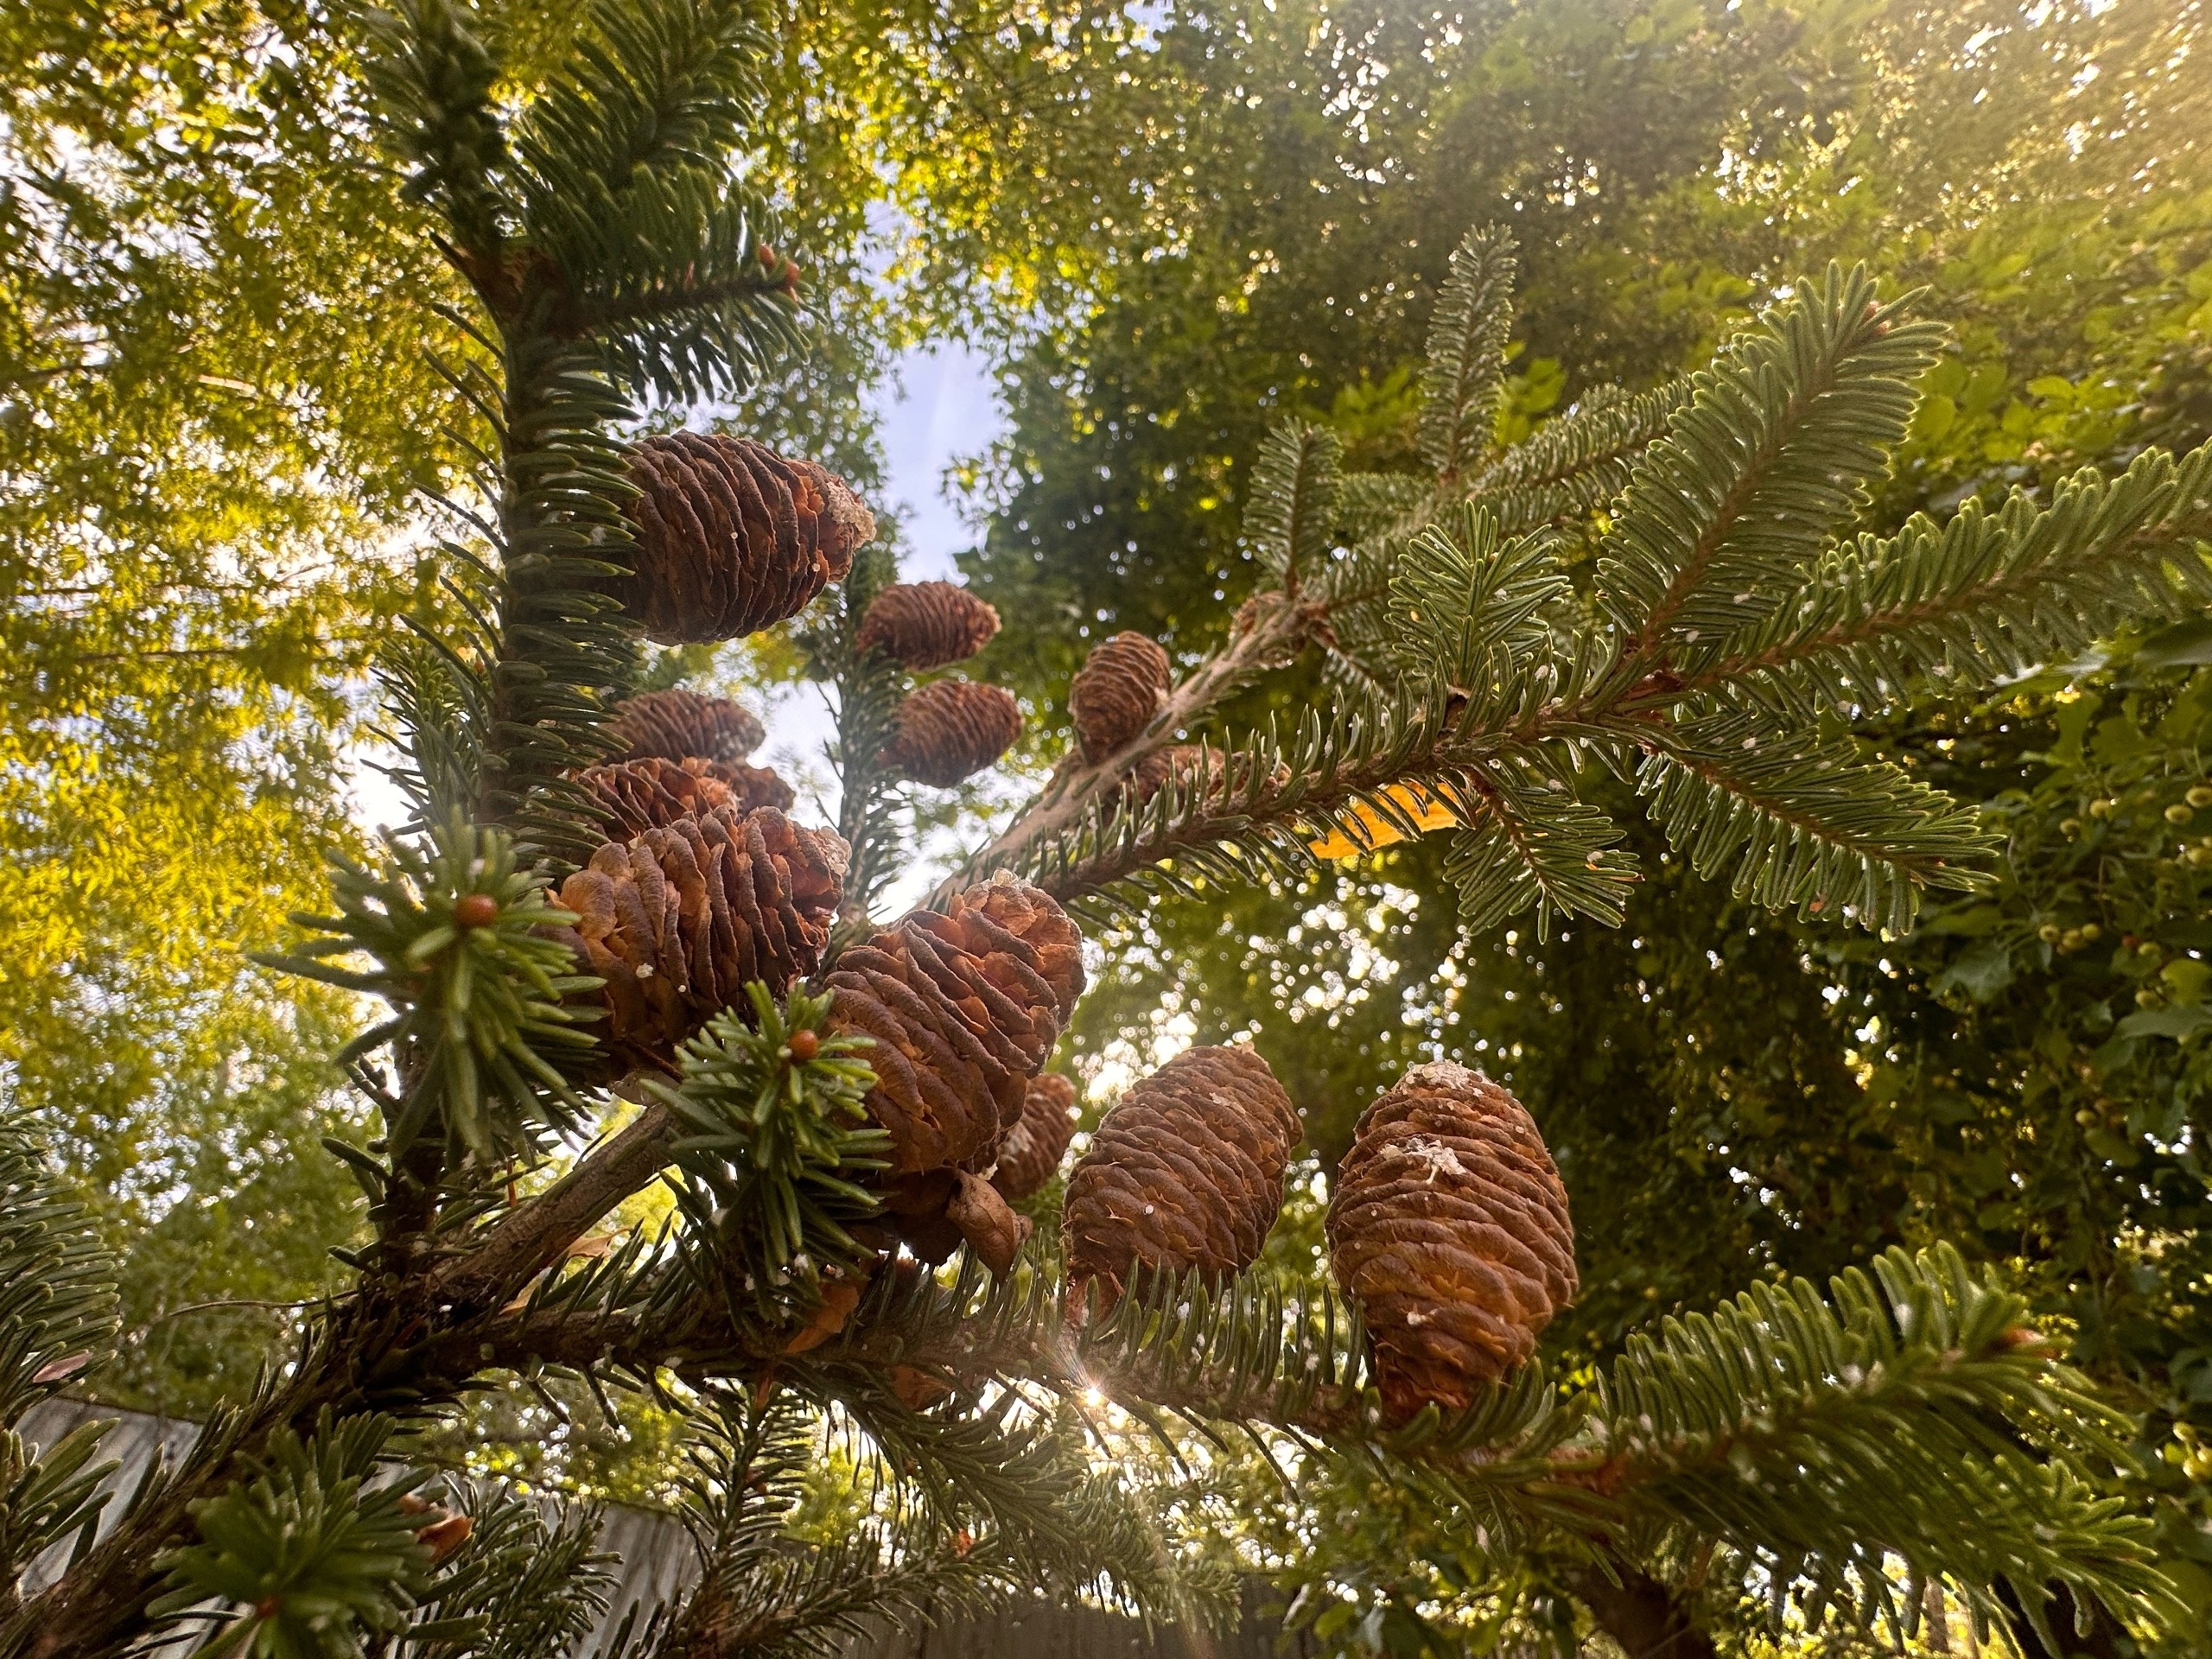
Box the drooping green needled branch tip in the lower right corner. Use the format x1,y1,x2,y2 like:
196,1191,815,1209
1597,1248,2188,1642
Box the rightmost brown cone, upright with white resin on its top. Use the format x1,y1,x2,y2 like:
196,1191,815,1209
1327,1062,1575,1418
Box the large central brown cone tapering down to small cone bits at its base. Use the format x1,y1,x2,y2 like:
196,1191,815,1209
823,876,1084,1268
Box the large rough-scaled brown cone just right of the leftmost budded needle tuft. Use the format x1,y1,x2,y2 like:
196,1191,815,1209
560,807,845,1071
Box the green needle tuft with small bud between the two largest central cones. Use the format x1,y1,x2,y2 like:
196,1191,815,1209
646,982,889,1319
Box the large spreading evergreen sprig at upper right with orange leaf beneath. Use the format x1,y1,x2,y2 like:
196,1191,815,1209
995,250,2212,933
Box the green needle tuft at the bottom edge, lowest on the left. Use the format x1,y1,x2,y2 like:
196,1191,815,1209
153,1415,429,1659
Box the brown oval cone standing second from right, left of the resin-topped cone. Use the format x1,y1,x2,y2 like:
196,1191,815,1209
1064,1046,1300,1300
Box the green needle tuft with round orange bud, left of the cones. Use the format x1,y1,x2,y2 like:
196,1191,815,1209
270,818,595,1167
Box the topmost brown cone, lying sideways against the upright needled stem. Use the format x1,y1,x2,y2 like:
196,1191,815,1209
608,431,876,646
